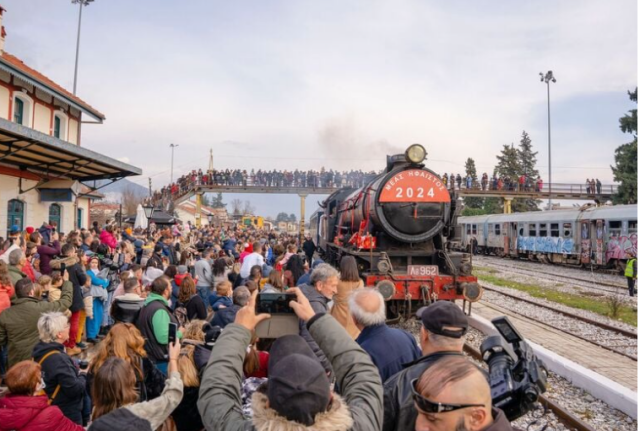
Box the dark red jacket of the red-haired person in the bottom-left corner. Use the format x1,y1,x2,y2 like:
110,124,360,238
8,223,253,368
0,395,84,431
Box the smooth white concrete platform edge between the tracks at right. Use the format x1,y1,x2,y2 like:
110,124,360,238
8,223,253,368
469,314,638,419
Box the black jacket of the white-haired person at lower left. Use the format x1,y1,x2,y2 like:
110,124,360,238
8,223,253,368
33,341,86,425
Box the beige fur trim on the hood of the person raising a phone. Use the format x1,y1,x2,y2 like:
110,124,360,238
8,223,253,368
251,392,353,431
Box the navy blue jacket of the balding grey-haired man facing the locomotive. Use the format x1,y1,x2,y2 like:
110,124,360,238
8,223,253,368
356,324,422,383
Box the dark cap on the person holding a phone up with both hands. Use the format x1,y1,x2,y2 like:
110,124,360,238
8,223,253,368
267,353,331,426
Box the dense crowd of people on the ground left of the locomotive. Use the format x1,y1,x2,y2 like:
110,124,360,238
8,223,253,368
0,222,524,431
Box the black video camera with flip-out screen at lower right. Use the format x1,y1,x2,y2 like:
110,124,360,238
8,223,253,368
480,316,547,422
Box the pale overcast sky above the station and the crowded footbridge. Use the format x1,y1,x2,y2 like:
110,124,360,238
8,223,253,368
0,0,638,213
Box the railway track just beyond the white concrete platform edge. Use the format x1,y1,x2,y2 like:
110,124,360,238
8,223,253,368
482,285,638,361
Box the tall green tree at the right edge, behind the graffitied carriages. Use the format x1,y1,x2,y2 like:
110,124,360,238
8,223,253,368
611,87,638,204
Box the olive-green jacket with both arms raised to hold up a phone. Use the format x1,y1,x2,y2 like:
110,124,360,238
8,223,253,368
198,315,383,431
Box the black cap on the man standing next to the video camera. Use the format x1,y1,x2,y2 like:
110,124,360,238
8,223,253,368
416,301,469,338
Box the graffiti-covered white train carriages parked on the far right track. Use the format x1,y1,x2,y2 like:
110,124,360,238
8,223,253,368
458,205,638,267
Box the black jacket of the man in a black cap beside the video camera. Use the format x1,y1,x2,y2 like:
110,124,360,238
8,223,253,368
382,352,463,431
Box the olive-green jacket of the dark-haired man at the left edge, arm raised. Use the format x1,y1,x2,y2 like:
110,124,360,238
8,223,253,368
0,281,73,368
